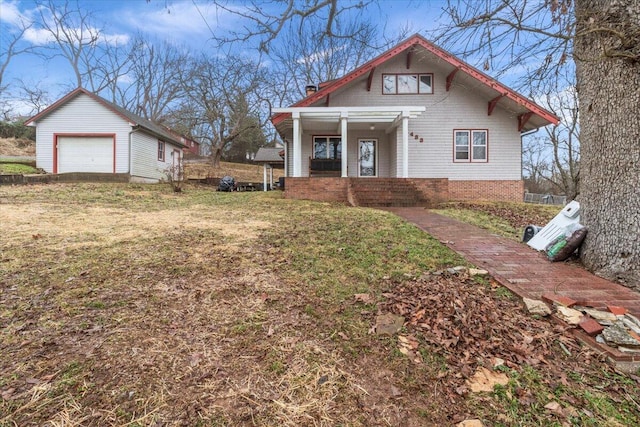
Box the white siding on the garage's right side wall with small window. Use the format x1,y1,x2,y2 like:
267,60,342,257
131,131,182,181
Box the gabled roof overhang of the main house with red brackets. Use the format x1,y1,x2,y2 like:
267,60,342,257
271,34,560,131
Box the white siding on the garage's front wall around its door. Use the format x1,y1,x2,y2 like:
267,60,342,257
36,94,131,173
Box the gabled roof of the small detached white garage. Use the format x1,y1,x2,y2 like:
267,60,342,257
25,87,186,147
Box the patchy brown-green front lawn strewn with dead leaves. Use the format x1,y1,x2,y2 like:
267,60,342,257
0,184,640,426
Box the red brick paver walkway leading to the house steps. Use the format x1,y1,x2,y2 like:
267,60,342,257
386,207,640,317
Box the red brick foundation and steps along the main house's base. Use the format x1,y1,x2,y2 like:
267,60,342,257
285,177,524,206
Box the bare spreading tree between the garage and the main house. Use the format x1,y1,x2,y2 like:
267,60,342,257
181,56,264,167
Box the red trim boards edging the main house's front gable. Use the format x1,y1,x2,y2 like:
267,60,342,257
271,34,560,126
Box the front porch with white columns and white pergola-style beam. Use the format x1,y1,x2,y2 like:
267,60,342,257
273,106,425,178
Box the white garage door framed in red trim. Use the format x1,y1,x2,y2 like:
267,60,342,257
58,136,113,173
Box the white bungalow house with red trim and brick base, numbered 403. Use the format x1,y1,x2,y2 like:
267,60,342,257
271,35,558,206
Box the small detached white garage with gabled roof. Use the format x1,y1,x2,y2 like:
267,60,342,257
26,88,186,182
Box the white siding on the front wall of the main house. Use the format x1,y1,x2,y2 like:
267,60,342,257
312,55,522,180
